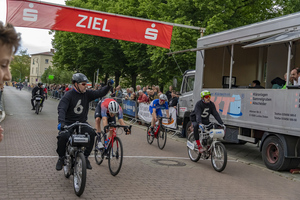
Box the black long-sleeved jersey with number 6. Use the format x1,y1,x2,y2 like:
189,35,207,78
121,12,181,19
57,86,110,125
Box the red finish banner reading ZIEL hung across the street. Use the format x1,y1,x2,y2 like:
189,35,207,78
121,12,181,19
6,0,173,49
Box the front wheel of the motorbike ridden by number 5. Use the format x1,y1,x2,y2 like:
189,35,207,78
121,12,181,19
211,142,227,172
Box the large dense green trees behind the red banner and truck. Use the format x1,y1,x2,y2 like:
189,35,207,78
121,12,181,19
53,0,292,92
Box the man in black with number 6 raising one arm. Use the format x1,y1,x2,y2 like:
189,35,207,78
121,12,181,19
56,73,114,170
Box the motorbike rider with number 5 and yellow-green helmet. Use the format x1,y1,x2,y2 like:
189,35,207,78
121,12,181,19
190,90,223,153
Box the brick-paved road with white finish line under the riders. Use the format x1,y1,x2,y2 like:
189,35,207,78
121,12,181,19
0,87,300,200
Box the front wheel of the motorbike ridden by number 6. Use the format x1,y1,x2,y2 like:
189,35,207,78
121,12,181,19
73,152,86,197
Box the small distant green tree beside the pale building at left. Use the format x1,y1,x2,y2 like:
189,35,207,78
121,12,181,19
10,50,30,82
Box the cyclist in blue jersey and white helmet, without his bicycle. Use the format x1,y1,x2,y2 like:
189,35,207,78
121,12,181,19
149,94,170,135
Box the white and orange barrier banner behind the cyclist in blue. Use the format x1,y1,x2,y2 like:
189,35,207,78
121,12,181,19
138,103,177,129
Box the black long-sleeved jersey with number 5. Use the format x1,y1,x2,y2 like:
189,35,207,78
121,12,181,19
191,100,223,125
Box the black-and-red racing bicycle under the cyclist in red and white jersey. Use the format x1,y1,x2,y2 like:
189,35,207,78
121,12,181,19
95,123,131,176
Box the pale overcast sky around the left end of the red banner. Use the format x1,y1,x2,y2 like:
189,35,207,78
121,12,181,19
0,0,65,54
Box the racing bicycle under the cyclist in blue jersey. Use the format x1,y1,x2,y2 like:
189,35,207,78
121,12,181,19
147,116,172,149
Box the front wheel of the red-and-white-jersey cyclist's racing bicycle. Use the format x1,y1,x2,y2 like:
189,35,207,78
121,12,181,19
108,137,123,176
